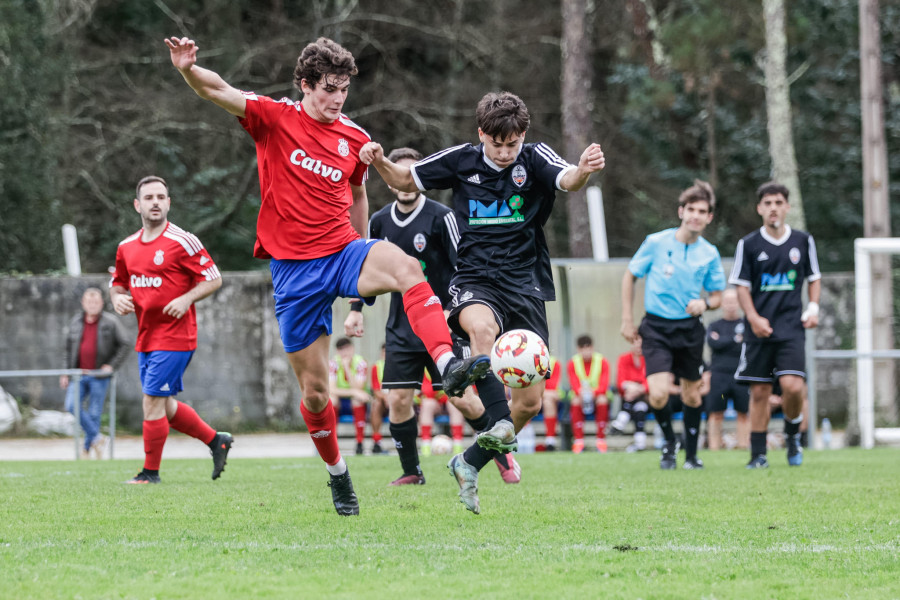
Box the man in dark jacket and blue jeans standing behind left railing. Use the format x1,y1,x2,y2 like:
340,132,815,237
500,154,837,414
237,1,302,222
59,287,130,459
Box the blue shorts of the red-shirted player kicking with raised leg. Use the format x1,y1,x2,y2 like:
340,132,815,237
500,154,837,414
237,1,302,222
269,239,378,352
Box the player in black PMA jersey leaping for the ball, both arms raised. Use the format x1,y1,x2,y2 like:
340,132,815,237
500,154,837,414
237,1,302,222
360,92,605,513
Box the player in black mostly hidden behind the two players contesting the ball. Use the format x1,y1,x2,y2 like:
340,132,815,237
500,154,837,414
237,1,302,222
344,148,520,485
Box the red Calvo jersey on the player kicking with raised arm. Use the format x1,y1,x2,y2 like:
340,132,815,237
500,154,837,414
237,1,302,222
240,92,371,260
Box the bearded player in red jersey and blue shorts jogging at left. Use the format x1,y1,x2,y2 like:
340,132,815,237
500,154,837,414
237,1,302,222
109,175,233,483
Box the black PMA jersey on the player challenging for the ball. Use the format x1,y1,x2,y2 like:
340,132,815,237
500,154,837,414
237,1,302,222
411,144,572,300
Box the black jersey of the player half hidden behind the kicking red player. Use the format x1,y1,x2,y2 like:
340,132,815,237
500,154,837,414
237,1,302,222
369,196,459,352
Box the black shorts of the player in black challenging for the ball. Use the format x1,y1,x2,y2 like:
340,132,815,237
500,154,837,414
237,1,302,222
447,283,550,348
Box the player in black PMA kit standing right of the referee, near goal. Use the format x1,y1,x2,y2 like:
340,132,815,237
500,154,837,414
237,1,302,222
729,182,822,469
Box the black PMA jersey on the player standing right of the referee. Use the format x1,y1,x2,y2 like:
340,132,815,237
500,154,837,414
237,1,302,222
728,226,822,341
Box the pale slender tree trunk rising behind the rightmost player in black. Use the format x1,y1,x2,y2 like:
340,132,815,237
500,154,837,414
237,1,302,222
763,0,806,231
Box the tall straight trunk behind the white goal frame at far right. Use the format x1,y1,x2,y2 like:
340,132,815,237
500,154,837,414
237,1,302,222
859,0,897,423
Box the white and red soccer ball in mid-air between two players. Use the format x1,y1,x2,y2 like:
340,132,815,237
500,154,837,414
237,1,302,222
491,329,550,388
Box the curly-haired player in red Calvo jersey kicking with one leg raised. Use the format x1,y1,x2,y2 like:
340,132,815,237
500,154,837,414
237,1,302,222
165,37,490,515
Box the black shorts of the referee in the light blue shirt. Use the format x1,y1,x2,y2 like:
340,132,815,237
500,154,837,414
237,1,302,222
638,315,706,381
